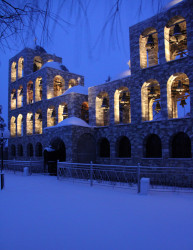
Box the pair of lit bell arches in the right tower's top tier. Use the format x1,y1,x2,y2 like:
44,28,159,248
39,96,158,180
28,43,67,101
139,16,188,68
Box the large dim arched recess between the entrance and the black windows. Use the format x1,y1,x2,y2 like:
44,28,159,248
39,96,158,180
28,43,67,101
77,134,96,163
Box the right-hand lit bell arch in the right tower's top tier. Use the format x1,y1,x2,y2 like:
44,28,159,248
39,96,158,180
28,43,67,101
164,16,188,62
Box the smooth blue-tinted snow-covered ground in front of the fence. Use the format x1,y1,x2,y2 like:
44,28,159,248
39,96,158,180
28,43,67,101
0,173,193,250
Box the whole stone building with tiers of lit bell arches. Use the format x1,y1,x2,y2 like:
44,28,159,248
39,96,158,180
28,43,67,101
9,0,193,170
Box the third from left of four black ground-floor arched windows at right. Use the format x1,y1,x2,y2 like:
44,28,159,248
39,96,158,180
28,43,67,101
145,134,162,158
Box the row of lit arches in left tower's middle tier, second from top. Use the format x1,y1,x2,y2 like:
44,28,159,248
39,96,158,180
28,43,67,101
10,75,78,109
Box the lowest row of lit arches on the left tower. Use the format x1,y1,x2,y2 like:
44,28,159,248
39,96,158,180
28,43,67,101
10,102,89,137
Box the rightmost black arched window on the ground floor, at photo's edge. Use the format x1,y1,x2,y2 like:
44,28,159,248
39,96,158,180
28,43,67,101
170,132,192,158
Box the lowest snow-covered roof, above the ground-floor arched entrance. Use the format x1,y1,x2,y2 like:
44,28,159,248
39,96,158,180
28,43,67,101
45,116,90,129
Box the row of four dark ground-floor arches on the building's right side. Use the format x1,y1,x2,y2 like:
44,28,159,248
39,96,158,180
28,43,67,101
98,132,192,158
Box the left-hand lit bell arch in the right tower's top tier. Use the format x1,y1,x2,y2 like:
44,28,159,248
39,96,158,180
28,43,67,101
139,28,158,69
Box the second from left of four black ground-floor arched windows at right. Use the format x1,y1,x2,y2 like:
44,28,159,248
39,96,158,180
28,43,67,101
117,136,131,158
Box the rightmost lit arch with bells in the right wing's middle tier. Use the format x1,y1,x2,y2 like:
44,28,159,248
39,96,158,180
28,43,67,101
167,73,190,119
